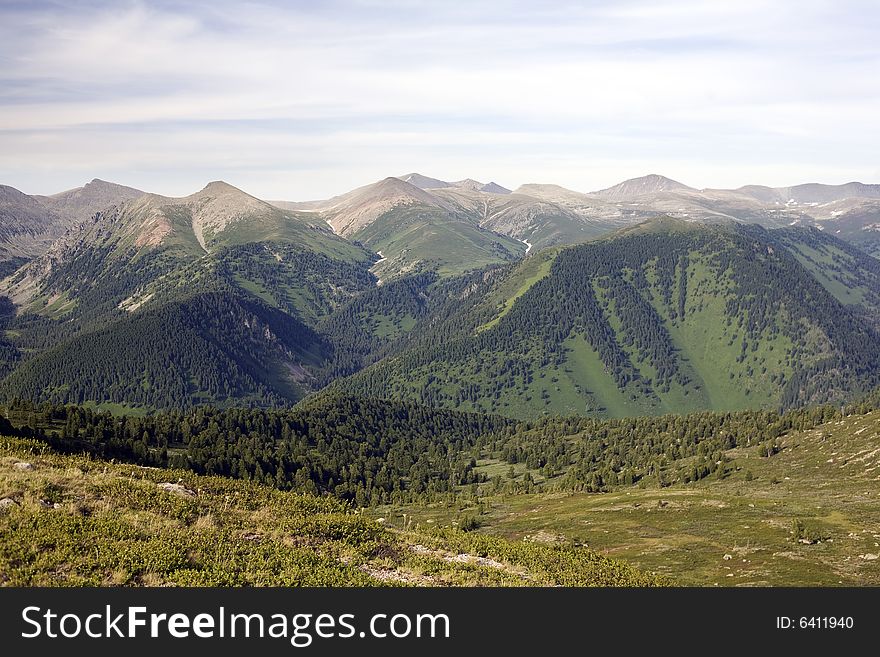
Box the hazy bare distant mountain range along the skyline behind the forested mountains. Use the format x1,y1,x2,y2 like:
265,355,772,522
0,173,880,279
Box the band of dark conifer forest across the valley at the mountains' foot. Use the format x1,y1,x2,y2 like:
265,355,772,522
6,394,878,506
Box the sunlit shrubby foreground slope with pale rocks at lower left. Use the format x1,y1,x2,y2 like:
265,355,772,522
0,437,660,586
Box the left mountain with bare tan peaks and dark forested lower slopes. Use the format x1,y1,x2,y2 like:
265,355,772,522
0,183,377,412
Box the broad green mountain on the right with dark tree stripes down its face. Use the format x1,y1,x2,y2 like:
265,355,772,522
338,220,880,417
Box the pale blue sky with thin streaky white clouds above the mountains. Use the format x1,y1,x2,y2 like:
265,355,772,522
0,0,880,200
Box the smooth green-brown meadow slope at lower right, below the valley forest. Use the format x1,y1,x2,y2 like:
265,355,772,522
381,412,880,586
